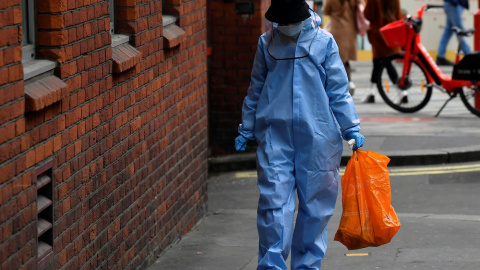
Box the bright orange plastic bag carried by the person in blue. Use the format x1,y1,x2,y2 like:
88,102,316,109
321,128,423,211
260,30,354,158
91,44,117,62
334,149,400,250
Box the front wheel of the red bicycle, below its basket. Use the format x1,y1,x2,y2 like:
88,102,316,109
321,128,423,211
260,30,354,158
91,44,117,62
377,54,432,113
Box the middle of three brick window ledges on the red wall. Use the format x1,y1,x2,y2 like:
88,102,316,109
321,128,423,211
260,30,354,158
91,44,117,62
112,43,142,73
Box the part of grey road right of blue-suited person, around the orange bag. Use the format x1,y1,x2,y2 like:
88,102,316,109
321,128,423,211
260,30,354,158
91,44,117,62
323,163,480,270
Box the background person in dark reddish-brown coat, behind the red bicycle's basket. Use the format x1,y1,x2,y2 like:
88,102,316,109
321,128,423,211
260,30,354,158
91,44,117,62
362,0,402,103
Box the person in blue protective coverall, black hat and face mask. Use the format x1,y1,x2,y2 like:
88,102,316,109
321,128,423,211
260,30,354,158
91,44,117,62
235,0,364,270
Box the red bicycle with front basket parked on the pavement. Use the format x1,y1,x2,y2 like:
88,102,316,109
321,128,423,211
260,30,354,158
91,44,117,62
377,5,480,117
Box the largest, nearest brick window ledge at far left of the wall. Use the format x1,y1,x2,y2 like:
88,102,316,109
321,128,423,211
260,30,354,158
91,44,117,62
25,76,68,112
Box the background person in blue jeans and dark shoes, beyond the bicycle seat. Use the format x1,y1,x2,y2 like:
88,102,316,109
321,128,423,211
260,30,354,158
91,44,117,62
437,0,470,66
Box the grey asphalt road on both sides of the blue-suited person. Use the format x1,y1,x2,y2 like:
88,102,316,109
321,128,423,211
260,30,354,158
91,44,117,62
148,162,480,270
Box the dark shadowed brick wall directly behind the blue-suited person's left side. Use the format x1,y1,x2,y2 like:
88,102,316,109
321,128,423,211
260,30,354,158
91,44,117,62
208,0,270,156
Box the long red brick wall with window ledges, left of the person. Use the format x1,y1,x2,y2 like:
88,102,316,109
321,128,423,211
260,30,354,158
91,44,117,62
0,0,208,270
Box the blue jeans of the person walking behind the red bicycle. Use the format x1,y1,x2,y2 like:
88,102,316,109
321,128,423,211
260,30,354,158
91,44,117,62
438,1,470,58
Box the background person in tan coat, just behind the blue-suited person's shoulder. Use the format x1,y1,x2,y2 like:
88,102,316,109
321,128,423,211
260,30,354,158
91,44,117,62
323,0,363,95
